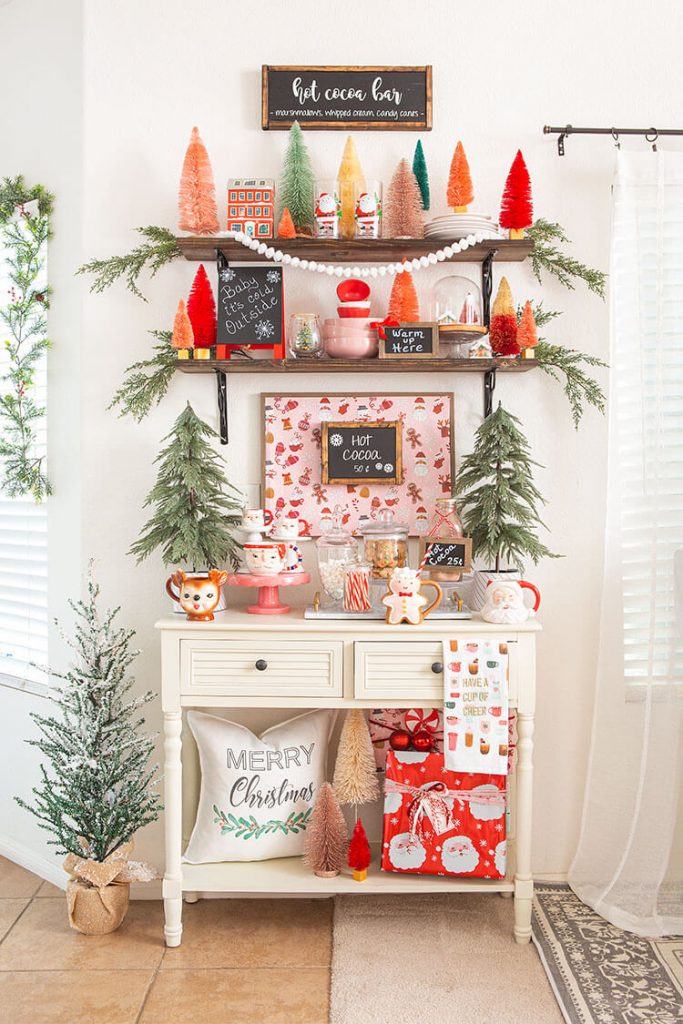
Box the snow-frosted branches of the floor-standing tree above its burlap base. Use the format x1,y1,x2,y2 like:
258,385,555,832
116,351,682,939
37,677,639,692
17,574,161,862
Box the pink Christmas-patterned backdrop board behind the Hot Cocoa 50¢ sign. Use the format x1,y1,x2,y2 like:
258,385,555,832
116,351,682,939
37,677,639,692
262,391,454,537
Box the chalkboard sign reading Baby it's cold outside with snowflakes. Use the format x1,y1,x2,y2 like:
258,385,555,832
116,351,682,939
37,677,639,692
216,256,285,348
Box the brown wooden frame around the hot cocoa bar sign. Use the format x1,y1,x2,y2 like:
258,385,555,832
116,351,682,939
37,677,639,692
261,65,432,131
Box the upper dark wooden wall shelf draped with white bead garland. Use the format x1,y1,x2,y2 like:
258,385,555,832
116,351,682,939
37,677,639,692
177,234,531,263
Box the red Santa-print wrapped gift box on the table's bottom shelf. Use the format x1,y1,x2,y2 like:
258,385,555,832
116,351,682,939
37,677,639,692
382,751,507,879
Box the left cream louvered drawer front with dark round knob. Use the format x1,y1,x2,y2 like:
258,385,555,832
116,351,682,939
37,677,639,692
180,637,343,699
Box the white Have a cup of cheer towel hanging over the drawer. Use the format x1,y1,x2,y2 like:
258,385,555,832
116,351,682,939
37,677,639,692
443,638,509,775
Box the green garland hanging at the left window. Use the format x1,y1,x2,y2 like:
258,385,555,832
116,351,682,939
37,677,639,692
0,176,54,502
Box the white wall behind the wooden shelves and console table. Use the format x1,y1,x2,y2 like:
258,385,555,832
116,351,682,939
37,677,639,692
5,0,683,873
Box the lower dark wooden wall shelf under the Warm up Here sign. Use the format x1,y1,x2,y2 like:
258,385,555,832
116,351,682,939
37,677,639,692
175,357,539,375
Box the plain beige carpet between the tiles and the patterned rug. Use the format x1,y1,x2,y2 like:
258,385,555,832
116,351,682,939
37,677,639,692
330,893,563,1024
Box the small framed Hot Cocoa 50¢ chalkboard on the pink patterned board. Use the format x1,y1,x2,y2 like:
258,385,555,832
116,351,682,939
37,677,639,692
323,420,403,483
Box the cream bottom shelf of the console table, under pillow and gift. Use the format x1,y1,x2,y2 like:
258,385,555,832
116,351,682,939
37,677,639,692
182,842,515,896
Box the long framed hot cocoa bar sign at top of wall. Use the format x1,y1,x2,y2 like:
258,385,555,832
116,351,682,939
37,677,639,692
261,65,432,131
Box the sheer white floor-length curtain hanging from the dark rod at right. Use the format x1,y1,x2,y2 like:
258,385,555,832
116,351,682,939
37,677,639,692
569,152,683,936
